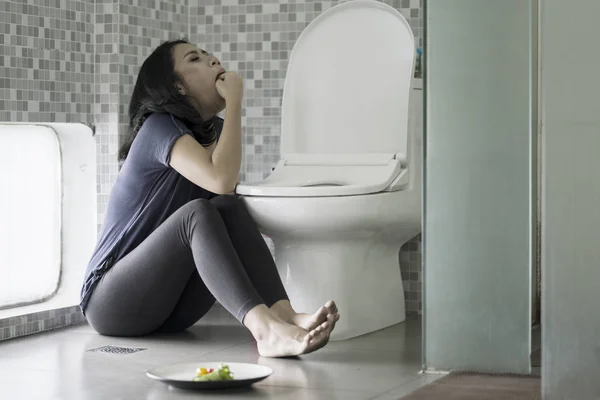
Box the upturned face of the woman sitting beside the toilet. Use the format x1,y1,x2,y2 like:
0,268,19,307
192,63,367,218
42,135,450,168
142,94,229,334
173,43,225,119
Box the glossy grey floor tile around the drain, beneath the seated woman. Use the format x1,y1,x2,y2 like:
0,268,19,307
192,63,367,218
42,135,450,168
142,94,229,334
0,310,253,372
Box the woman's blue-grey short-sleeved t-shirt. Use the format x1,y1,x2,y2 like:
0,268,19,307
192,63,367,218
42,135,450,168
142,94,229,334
80,113,223,313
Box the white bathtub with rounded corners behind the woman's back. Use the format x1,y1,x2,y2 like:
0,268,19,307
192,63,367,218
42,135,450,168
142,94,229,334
0,122,97,319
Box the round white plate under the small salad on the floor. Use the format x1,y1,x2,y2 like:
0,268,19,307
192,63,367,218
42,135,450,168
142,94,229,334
146,361,273,389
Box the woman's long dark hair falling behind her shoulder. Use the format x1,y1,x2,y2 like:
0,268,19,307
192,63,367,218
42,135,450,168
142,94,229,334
119,39,217,162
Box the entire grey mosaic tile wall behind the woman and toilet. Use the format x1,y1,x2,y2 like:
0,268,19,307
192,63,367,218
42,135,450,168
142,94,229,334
0,0,422,340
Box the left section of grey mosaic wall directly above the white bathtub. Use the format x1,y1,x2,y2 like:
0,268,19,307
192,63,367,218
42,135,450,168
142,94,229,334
0,0,94,122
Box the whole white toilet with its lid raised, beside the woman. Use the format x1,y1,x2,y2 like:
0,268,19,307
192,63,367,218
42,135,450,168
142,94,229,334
236,0,422,340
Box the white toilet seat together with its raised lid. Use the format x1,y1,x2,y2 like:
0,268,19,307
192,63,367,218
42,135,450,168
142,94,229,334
236,0,418,198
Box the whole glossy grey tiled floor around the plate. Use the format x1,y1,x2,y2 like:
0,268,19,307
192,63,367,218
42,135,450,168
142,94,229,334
0,308,438,400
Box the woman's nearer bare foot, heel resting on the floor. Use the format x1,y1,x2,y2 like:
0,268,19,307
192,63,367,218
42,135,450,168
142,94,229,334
256,314,334,357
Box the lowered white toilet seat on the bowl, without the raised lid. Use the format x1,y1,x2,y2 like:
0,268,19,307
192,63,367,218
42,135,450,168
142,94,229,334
236,153,408,197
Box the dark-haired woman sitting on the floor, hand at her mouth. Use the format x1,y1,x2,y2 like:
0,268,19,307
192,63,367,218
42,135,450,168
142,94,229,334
81,40,339,357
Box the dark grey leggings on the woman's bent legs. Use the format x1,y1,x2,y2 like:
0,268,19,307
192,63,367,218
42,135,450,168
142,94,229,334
86,195,288,336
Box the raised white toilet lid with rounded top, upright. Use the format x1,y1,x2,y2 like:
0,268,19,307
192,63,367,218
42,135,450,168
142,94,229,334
281,0,415,159
